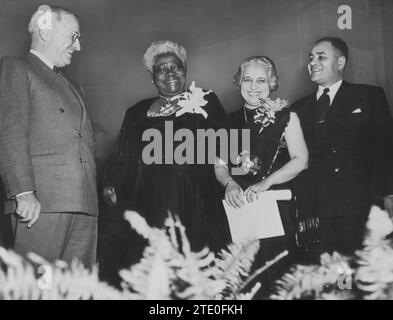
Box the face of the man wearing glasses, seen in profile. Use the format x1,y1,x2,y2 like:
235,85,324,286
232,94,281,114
47,13,81,68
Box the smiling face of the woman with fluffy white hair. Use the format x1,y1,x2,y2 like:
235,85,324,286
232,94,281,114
153,53,186,97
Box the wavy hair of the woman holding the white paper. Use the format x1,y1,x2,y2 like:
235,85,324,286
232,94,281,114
233,56,278,91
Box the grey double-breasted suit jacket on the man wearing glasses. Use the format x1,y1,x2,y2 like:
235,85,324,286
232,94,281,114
0,54,98,215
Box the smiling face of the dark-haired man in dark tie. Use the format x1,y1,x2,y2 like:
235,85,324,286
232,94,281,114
308,41,345,87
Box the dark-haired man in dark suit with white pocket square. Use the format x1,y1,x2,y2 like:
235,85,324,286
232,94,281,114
292,37,393,253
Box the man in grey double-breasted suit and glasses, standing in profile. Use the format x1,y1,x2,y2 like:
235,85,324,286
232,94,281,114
0,6,98,266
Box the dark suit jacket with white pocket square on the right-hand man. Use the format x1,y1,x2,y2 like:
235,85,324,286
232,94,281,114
291,81,393,218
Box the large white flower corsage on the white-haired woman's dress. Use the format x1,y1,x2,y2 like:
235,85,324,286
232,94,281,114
176,81,212,119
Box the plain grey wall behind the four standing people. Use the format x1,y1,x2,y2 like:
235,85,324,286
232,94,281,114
0,0,393,163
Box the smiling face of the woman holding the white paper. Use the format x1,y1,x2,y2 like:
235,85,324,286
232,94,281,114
240,63,270,109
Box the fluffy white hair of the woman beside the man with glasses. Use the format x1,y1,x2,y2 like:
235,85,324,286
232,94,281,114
143,40,187,73
